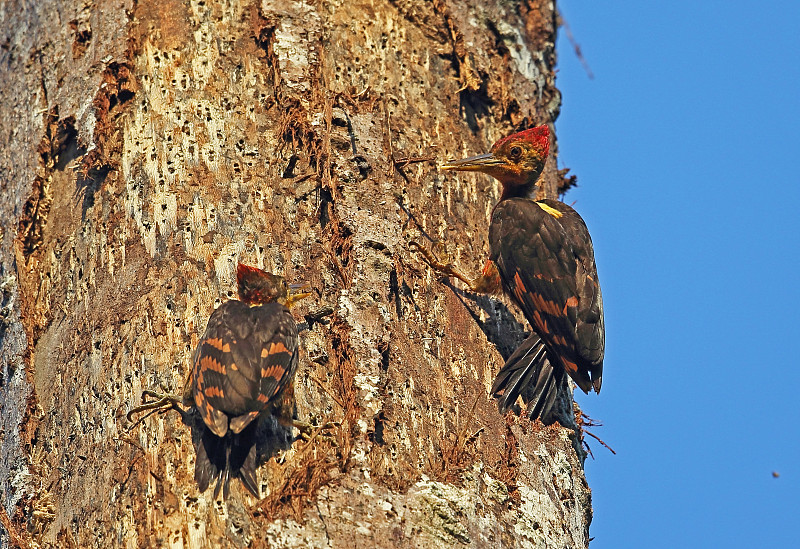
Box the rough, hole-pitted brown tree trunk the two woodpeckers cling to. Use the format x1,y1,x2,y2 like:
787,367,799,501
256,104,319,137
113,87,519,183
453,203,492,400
0,0,591,548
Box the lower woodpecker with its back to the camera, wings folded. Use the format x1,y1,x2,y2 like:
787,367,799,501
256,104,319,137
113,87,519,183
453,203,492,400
187,263,310,499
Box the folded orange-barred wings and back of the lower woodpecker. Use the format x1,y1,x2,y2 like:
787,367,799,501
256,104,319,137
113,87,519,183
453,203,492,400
192,300,297,437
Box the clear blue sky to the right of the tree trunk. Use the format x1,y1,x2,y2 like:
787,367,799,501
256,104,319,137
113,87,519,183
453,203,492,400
556,0,800,549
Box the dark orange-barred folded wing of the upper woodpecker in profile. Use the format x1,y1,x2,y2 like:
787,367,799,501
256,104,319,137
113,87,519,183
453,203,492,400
489,198,605,392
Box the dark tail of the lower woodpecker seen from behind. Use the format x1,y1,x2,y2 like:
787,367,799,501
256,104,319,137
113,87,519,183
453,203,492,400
194,422,261,499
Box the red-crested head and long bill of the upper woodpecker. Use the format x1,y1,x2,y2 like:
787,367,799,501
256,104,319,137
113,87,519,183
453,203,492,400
441,125,550,194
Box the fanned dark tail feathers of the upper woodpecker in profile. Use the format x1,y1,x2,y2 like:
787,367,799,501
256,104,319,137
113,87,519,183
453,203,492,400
492,333,563,423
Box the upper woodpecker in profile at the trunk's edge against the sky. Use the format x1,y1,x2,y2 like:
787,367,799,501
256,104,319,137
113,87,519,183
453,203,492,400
434,126,605,423
